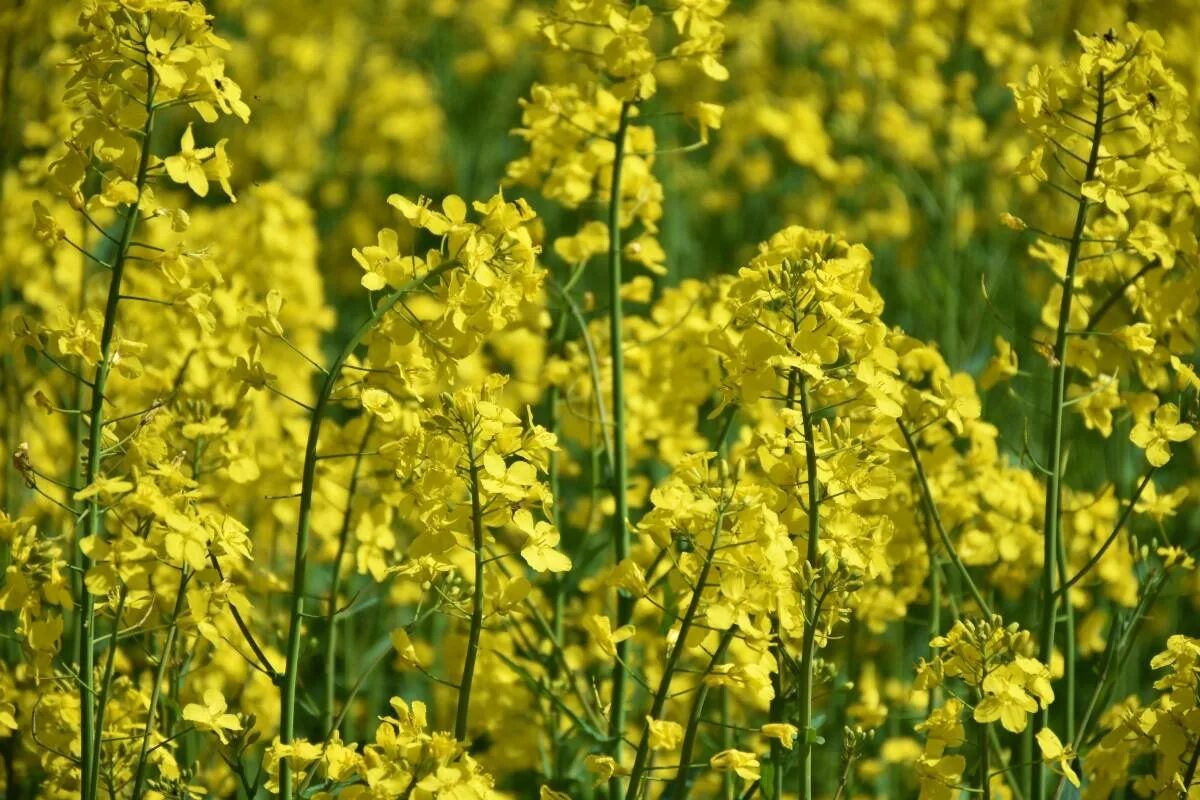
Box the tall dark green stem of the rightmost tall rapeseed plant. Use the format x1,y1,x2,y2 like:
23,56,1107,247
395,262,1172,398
1032,72,1105,800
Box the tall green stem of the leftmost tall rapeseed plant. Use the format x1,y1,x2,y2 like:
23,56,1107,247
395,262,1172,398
74,62,156,800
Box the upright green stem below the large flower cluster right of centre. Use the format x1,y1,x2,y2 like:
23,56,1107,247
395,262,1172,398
796,373,821,800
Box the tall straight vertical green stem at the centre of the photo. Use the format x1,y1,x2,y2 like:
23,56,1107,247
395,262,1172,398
608,102,634,799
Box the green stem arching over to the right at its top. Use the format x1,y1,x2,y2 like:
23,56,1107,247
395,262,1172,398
280,260,457,800
